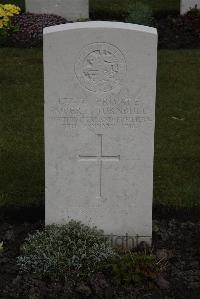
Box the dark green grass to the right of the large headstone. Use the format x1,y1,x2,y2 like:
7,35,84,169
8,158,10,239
154,50,200,207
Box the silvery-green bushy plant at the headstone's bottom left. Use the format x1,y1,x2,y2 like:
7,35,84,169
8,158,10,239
17,221,115,278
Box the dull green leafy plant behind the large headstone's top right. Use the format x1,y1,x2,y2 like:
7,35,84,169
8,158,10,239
126,1,154,26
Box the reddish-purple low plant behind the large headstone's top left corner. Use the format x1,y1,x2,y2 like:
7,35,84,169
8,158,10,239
1,13,67,48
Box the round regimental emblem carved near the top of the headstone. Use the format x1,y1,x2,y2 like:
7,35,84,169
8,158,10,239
75,43,126,92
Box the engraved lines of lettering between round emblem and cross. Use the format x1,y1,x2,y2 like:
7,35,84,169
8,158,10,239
51,90,152,129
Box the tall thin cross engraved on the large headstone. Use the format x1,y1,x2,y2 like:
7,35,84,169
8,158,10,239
79,134,120,199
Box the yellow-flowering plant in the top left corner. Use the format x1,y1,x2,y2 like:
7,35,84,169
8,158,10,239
0,4,21,37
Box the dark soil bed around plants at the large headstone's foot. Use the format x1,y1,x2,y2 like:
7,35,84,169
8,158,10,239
0,210,200,299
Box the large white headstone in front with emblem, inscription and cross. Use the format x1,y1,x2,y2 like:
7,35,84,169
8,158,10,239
44,22,157,248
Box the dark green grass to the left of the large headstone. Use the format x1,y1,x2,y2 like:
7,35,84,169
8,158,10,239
0,48,44,206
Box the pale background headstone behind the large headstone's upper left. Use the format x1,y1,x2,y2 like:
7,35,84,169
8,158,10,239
26,0,89,21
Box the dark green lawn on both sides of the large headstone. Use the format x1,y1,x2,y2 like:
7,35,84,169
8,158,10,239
0,48,200,207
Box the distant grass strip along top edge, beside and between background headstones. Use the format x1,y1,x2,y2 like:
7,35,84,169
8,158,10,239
0,0,180,19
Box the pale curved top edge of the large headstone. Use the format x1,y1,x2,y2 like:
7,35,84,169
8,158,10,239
43,21,157,35
